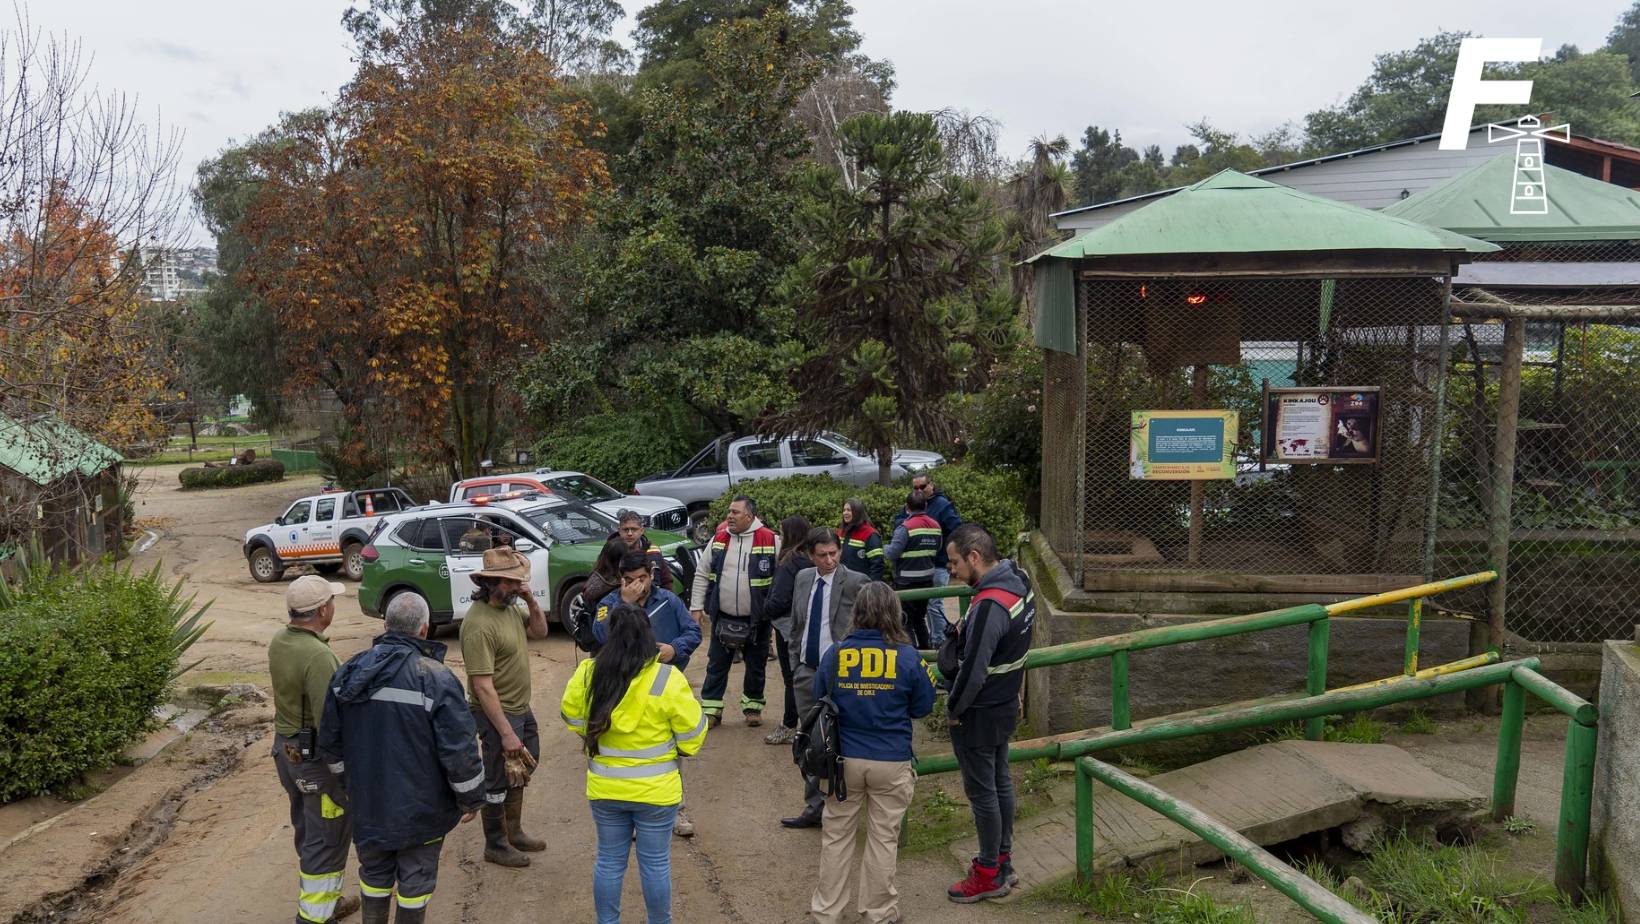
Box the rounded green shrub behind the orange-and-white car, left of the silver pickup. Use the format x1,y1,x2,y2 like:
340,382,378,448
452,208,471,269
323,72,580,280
535,409,710,491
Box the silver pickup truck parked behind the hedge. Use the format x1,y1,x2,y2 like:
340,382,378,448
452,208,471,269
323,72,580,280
633,433,945,535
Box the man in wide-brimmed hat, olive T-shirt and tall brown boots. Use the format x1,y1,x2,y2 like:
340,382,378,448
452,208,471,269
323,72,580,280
461,547,546,867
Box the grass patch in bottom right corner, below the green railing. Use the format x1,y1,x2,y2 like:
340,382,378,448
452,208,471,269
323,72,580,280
1301,832,1617,924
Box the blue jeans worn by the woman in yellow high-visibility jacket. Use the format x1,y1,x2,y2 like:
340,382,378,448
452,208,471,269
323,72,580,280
590,799,677,924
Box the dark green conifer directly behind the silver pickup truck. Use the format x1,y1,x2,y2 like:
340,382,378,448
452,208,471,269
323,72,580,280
783,112,1018,484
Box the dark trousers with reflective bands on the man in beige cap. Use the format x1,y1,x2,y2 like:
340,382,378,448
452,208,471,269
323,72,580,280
274,735,353,924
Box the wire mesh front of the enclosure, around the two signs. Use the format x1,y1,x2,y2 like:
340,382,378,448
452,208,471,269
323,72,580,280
1069,276,1445,576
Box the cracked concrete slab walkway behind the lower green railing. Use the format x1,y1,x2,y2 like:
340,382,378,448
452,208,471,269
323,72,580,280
951,742,1486,893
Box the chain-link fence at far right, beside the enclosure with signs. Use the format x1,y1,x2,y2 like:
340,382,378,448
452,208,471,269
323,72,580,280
1437,241,1640,643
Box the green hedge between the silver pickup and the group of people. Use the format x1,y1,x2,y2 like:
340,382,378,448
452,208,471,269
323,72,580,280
710,464,1025,553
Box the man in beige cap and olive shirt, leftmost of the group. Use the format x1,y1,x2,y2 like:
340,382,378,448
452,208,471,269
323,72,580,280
267,574,359,924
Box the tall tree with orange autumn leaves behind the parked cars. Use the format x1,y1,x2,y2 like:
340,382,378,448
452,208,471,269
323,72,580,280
238,3,605,476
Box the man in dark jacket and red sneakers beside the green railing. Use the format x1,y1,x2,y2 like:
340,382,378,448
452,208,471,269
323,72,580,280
946,524,1036,903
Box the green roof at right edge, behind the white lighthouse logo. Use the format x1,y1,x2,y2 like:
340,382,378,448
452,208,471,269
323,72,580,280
1384,153,1640,241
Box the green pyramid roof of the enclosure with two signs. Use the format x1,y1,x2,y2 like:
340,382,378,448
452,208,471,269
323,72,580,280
1032,171,1499,259
